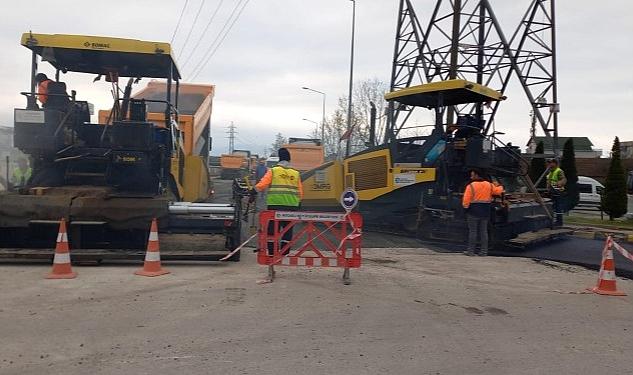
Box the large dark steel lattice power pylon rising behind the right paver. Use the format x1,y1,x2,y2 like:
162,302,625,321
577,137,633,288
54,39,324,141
385,0,558,153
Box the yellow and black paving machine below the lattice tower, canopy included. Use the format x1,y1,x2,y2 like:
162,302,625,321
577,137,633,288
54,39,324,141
302,79,564,246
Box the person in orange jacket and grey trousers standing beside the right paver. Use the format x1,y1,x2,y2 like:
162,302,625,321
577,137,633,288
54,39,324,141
462,169,503,256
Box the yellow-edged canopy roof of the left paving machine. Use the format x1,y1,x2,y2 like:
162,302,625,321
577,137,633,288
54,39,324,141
21,33,180,80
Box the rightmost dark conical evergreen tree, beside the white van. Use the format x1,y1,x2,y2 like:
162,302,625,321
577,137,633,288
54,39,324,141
601,137,627,220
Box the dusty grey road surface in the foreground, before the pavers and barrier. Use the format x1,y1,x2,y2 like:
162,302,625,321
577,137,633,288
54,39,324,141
0,249,633,375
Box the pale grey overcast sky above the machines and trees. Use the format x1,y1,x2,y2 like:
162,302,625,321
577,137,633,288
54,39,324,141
0,0,633,154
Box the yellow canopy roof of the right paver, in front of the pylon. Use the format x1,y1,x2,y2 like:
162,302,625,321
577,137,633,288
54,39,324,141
385,79,505,108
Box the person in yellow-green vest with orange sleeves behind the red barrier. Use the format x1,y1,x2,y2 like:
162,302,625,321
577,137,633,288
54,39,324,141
253,148,303,254
